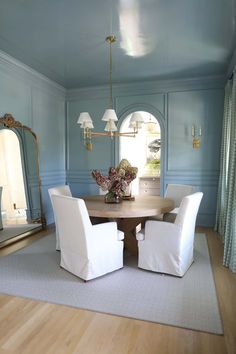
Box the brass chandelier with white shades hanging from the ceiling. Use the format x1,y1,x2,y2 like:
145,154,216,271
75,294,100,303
77,35,144,151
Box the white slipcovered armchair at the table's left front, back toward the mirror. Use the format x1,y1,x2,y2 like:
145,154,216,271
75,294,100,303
52,194,124,280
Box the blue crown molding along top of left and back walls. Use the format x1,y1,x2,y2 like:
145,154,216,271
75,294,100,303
0,46,226,101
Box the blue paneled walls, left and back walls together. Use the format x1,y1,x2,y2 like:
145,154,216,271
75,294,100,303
0,52,224,226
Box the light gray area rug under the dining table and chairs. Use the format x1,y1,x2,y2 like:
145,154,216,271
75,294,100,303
0,234,223,334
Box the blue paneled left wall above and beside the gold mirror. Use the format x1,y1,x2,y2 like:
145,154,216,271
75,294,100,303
0,52,65,223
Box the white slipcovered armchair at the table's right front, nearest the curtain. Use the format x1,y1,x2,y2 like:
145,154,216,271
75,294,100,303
136,192,203,277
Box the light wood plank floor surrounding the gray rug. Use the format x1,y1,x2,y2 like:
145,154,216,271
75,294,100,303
0,228,236,354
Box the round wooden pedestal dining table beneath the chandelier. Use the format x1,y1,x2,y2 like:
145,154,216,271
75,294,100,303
83,195,174,254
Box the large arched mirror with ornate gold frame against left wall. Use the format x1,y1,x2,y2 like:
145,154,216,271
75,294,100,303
0,114,44,247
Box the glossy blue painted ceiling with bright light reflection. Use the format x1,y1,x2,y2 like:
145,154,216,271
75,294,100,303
0,0,236,88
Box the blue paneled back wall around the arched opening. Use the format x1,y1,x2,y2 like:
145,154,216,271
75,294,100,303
67,78,224,226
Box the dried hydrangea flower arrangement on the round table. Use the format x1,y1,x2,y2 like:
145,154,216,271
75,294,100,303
92,159,138,202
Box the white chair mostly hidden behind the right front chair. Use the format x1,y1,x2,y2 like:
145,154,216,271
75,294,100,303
163,184,196,222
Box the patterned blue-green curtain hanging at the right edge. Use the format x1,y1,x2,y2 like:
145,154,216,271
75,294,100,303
215,70,236,272
